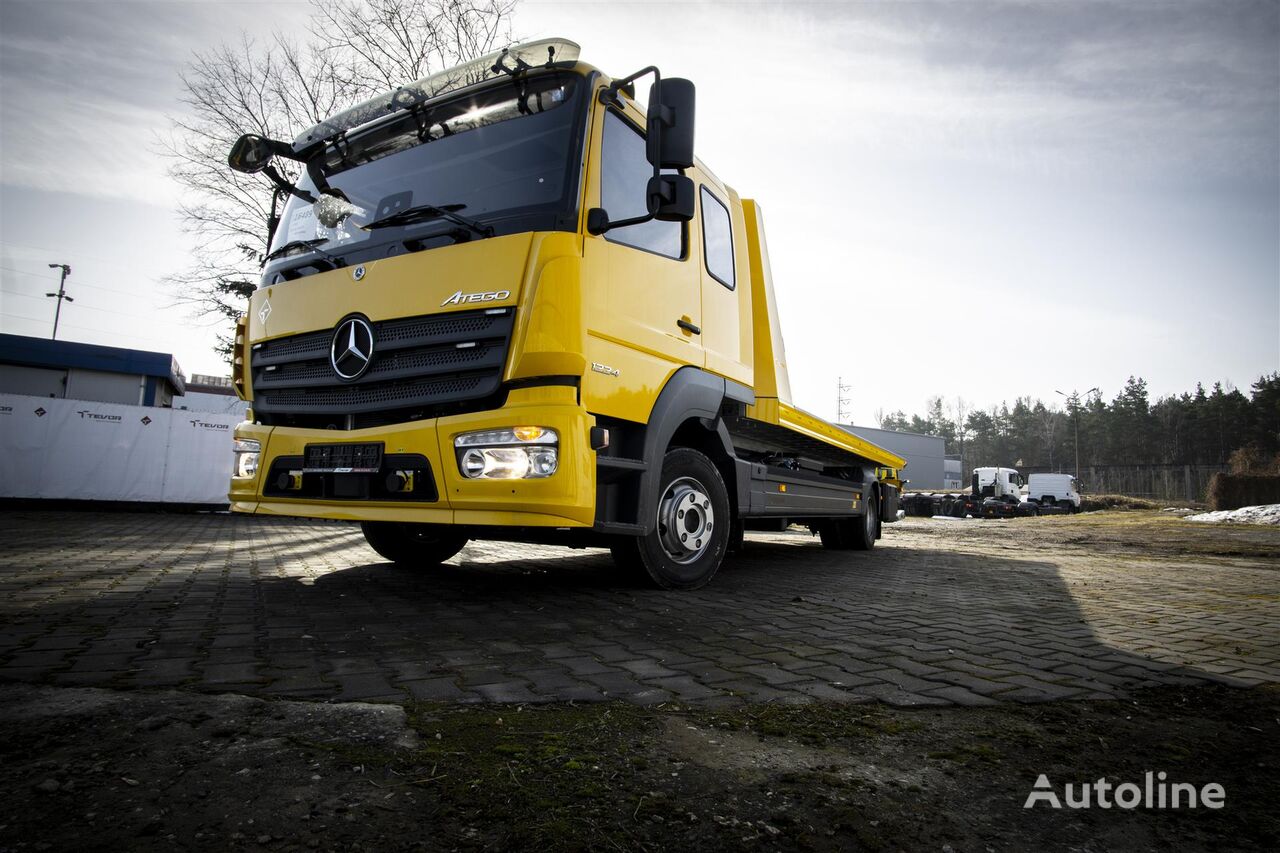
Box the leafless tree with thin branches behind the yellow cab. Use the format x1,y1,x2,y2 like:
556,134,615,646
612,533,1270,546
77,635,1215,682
161,0,518,355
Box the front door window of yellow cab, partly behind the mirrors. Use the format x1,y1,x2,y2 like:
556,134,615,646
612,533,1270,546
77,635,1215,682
600,110,685,260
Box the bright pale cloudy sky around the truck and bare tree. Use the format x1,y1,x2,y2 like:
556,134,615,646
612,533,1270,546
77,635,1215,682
0,0,1280,425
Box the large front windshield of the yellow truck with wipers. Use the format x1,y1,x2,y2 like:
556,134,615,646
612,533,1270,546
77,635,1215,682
271,73,585,274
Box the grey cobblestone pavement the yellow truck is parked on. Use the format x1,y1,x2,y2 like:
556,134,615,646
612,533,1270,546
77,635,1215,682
0,511,1280,706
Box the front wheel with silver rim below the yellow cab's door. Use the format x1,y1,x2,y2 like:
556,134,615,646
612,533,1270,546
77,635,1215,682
612,447,733,589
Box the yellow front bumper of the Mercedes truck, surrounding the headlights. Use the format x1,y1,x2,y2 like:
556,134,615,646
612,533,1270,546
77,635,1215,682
229,387,595,526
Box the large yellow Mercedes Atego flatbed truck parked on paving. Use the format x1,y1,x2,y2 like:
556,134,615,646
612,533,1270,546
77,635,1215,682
222,40,904,589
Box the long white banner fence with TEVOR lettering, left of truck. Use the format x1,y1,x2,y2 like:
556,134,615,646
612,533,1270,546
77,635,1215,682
0,394,241,503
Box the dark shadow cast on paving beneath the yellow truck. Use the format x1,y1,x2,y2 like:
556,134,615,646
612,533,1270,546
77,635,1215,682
247,537,1217,704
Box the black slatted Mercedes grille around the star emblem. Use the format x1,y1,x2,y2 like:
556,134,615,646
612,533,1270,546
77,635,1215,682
250,309,515,429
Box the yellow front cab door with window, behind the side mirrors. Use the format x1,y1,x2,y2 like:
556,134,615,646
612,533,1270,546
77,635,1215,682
582,105,705,421
